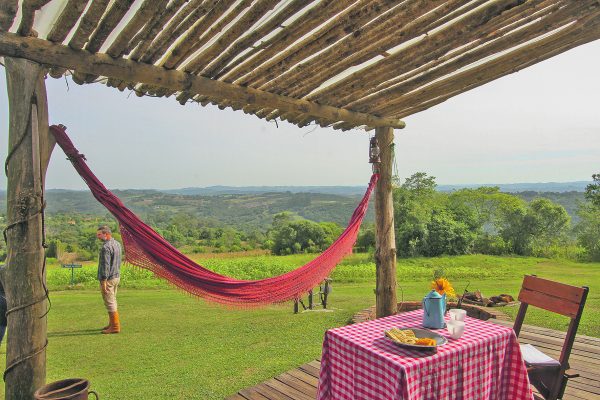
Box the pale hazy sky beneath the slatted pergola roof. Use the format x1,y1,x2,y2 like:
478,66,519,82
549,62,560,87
0,41,600,189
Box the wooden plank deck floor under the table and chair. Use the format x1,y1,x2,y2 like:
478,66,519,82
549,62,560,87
227,320,600,400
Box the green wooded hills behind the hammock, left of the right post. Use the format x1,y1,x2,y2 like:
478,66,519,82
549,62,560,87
0,189,374,230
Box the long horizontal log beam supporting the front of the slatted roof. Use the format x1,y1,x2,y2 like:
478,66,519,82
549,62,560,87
0,32,405,128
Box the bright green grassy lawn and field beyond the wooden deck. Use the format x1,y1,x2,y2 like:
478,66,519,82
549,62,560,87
0,255,600,399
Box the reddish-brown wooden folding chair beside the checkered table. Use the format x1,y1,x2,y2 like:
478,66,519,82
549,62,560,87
514,275,589,400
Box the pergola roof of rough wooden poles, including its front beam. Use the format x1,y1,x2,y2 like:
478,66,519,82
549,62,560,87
0,0,600,131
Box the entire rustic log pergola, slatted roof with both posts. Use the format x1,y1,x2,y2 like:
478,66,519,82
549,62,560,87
0,0,600,400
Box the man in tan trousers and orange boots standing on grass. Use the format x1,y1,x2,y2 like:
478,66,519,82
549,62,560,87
96,225,121,333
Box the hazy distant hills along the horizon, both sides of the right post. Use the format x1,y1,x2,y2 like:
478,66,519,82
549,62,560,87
0,181,589,229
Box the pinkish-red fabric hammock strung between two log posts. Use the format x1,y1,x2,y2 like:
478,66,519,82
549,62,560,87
50,125,379,307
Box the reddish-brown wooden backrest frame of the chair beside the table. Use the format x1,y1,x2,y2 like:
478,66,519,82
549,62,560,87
514,275,589,371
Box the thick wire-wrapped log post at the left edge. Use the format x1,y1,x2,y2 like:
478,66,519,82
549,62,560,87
2,57,54,400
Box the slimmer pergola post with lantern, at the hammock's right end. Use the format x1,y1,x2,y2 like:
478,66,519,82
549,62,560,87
375,128,397,318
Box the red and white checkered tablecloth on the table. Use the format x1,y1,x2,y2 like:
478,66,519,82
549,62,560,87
317,310,533,400
